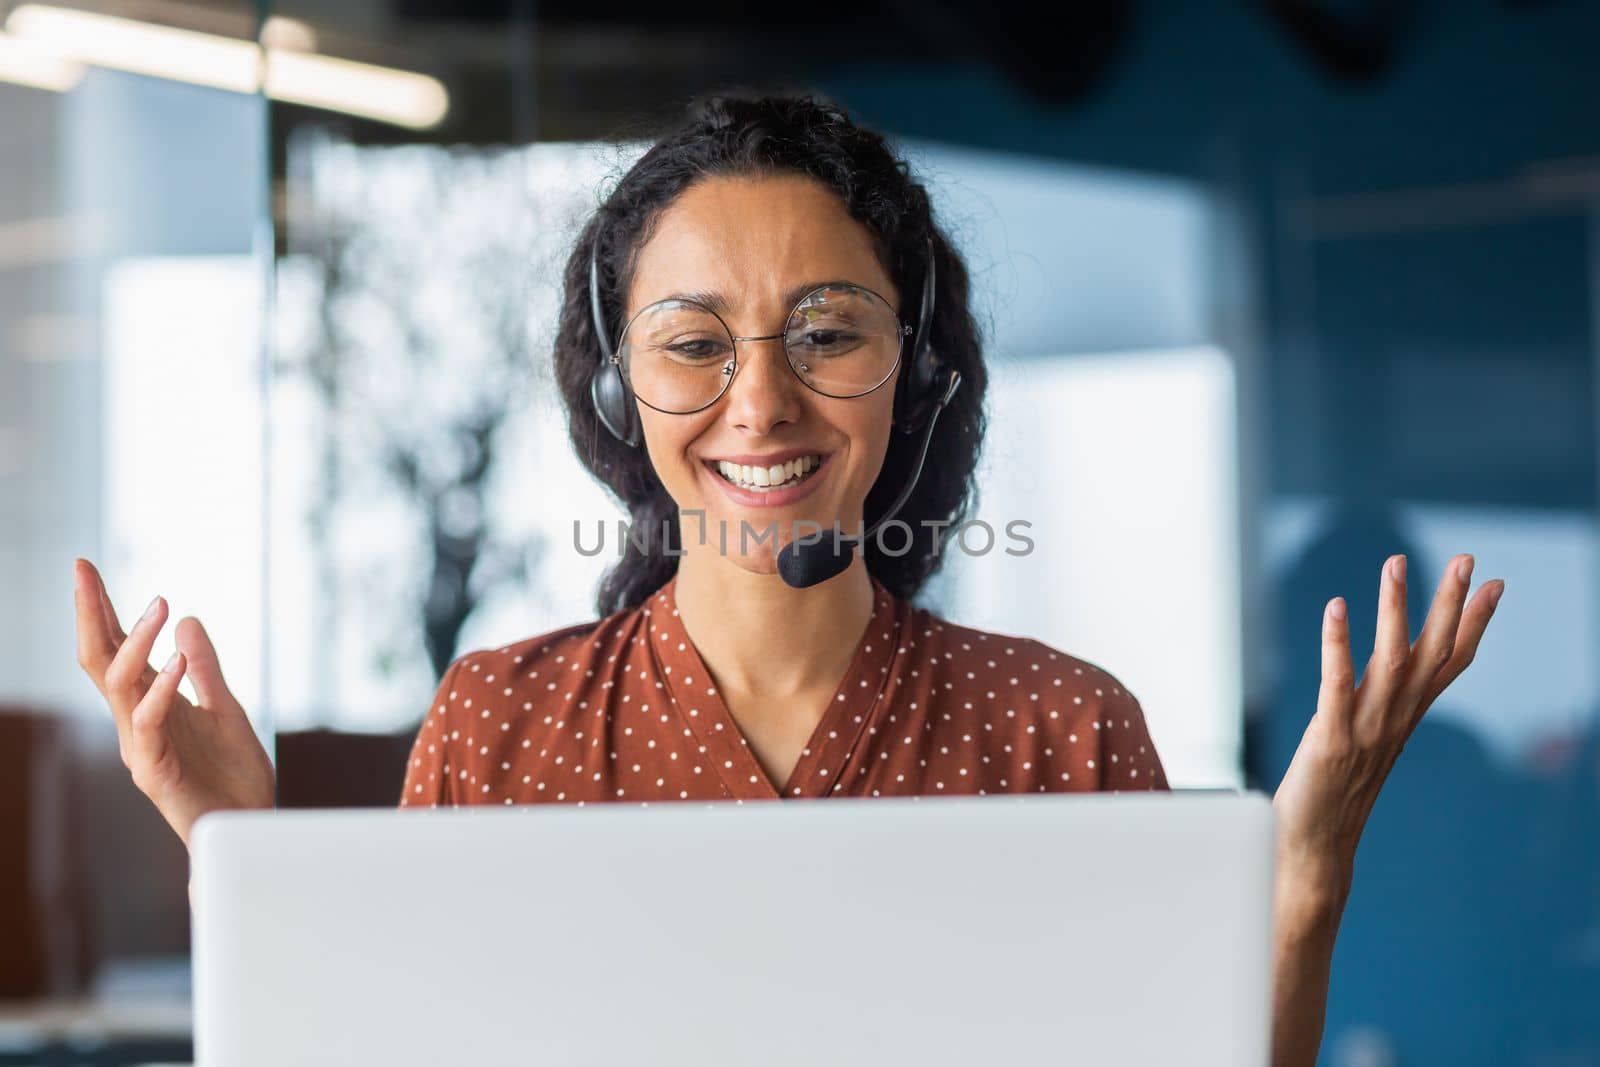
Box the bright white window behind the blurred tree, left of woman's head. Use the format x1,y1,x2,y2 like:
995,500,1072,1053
269,138,627,731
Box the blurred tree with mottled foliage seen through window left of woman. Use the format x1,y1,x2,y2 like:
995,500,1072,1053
280,139,546,678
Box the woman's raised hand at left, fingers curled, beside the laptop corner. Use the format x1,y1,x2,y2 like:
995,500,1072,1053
74,560,275,846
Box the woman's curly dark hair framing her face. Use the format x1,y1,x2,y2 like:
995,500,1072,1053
555,93,987,616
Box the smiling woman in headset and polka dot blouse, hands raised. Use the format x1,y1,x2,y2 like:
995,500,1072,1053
77,98,1504,1064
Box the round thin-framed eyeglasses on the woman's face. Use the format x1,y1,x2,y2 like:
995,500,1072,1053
611,283,912,414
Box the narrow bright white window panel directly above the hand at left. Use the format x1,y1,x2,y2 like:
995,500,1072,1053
102,256,267,748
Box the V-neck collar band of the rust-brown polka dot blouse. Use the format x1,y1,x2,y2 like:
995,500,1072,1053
648,574,901,800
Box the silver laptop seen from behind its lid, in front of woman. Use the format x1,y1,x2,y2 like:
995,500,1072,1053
192,792,1274,1067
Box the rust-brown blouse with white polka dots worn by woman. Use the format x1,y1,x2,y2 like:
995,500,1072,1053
400,577,1168,808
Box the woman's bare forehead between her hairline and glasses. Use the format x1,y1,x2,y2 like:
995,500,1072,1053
627,174,898,315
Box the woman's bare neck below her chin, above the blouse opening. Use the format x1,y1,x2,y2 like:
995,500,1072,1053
677,550,874,697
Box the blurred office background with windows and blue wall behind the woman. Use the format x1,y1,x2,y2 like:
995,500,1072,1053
0,0,1600,1067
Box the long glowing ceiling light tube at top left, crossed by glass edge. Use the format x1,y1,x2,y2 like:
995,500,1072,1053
6,3,450,130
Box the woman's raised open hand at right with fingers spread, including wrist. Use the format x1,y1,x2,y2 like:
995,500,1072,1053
1272,555,1506,921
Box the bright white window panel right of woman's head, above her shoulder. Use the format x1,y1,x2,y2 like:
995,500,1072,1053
941,347,1243,789
